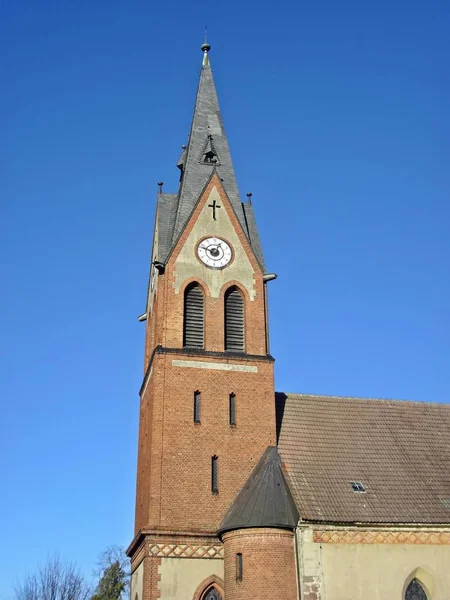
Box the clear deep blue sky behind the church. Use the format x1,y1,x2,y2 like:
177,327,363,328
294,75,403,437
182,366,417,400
0,0,450,599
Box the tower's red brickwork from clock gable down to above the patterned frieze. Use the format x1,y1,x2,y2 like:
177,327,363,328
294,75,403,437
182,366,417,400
132,176,275,533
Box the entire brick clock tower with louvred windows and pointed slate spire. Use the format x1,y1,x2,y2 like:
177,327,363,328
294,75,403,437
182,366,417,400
128,43,298,600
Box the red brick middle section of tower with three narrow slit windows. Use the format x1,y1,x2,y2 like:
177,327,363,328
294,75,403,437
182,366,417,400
136,354,275,531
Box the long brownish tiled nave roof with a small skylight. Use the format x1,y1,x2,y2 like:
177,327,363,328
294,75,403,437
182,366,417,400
276,394,450,524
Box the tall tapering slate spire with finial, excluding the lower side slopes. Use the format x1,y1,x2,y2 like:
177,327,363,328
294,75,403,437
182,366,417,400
173,42,246,242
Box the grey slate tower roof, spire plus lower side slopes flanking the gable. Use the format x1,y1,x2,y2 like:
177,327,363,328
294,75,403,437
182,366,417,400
158,52,264,270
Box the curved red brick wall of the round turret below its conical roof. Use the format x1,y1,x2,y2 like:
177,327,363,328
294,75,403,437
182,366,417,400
223,528,297,600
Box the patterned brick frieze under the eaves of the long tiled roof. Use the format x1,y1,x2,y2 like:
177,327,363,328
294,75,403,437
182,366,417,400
314,529,450,545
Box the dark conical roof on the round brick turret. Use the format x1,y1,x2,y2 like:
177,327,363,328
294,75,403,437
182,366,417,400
217,446,298,535
